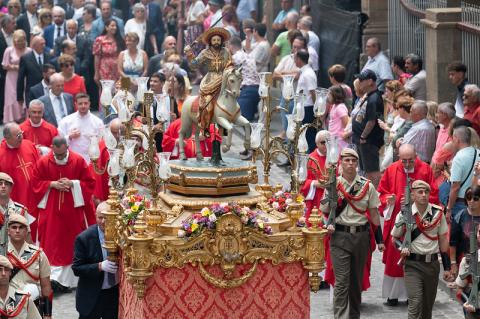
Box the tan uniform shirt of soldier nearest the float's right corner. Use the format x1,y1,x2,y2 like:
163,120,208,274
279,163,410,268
320,175,380,226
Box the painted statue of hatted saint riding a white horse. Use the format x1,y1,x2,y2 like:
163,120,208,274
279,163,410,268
179,28,250,162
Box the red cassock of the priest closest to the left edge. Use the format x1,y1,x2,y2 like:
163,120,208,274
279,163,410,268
0,139,40,217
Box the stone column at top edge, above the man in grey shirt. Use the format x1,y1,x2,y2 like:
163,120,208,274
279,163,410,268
362,0,388,50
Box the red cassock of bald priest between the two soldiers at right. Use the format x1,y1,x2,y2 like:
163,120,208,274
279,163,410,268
378,157,438,277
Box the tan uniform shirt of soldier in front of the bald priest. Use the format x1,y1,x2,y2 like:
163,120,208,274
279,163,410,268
391,203,448,255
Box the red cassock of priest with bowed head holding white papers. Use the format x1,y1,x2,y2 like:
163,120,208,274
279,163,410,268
32,151,96,266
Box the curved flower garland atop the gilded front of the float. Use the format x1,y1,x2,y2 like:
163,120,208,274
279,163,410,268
178,203,272,237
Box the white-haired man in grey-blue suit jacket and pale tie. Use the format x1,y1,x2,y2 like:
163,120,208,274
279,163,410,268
39,73,74,127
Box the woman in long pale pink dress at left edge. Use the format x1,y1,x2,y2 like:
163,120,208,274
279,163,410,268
2,30,31,123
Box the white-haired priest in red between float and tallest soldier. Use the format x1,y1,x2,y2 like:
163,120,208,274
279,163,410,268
301,130,330,220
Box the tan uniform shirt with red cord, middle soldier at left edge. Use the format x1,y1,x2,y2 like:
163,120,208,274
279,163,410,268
7,242,50,299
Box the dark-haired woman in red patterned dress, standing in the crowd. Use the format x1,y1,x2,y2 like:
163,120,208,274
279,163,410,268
93,19,125,85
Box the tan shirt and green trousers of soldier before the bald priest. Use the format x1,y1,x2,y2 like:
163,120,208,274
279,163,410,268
391,202,448,319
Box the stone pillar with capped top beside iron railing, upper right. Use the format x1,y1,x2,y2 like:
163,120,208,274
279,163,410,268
421,8,462,103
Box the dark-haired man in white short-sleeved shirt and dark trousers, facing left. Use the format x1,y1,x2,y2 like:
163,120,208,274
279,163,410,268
294,50,317,153
